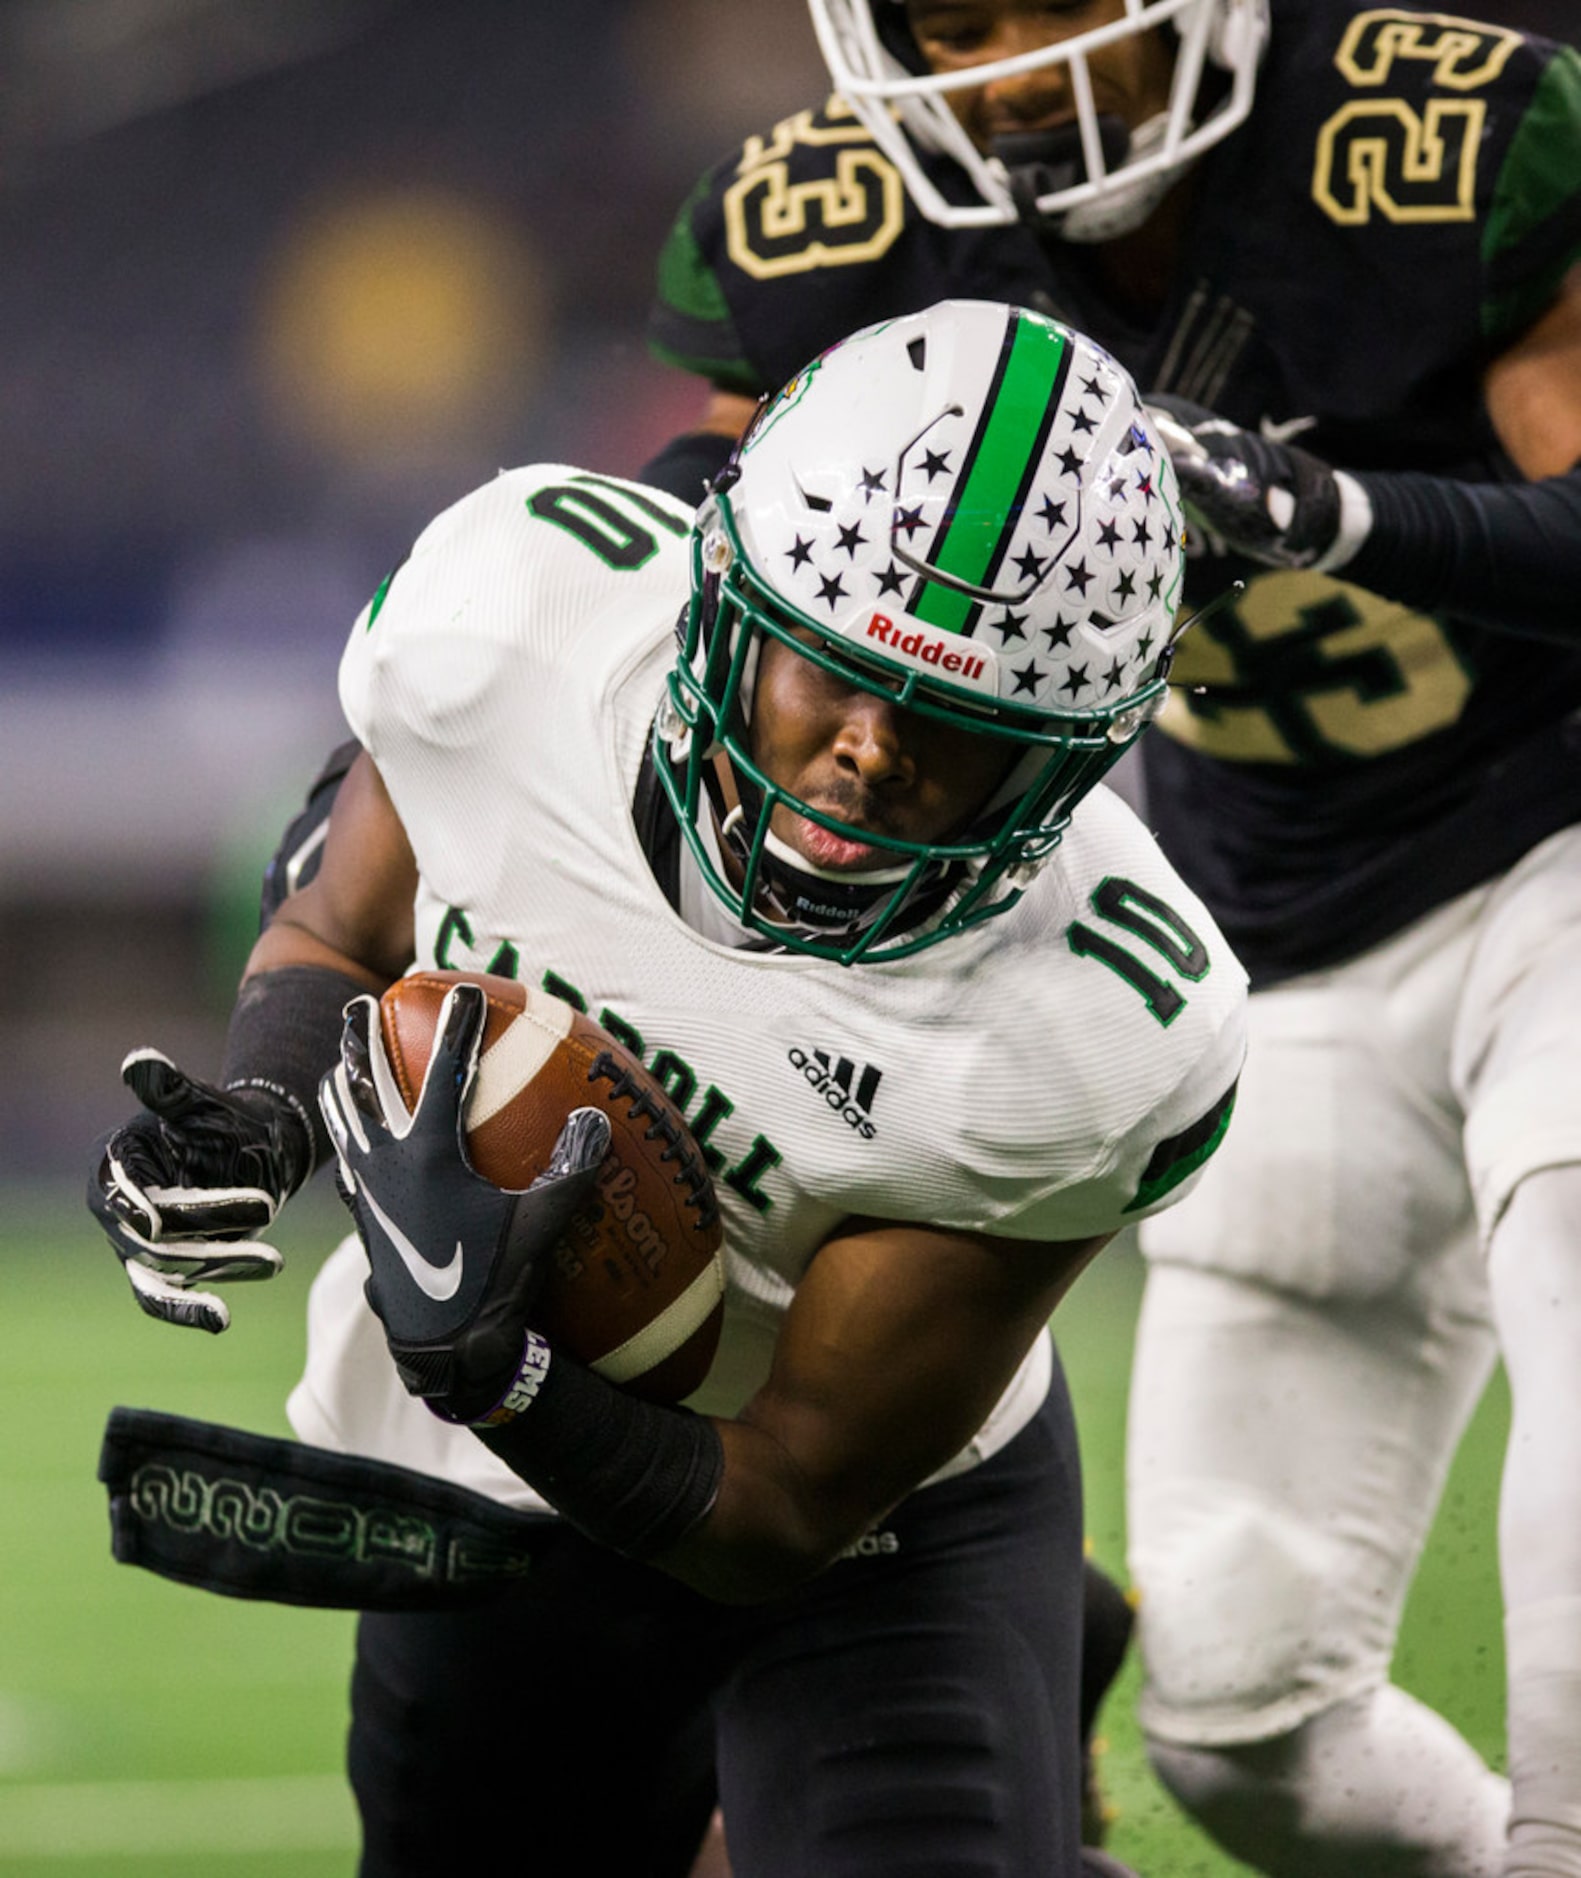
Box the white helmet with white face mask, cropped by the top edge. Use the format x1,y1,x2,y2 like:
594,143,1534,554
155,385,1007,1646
809,0,1267,240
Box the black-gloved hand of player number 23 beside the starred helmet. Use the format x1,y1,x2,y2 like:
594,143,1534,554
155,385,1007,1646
1147,396,1365,567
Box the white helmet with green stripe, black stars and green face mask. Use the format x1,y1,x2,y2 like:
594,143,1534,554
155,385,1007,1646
655,300,1183,963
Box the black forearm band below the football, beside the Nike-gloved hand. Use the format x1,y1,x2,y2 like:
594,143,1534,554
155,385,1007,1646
473,1332,725,1561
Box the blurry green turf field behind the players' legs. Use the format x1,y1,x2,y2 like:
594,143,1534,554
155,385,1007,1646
0,1191,1506,1878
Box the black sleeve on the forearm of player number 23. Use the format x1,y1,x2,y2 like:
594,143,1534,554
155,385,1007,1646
1337,464,1581,646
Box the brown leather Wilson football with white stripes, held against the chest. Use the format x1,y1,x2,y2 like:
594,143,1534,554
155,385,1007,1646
379,971,725,1403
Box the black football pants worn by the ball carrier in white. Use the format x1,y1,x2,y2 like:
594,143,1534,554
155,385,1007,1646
349,1371,1082,1878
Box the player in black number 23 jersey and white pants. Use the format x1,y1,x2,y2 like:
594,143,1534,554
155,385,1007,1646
652,0,1581,1878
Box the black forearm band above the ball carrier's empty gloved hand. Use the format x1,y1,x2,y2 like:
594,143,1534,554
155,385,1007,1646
220,965,368,1193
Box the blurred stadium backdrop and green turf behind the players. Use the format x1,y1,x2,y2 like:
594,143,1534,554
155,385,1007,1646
0,0,1506,1878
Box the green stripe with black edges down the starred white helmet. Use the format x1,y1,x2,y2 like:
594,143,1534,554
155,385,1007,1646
911,312,1070,633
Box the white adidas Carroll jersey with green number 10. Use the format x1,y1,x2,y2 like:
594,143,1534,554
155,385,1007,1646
291,464,1245,1504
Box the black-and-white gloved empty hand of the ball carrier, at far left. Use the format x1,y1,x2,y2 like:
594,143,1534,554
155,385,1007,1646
88,1050,312,1333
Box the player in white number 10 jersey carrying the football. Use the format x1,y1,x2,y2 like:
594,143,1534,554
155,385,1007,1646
94,302,1245,1878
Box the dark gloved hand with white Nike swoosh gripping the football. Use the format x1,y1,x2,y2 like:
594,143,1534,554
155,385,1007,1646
319,984,610,1422
